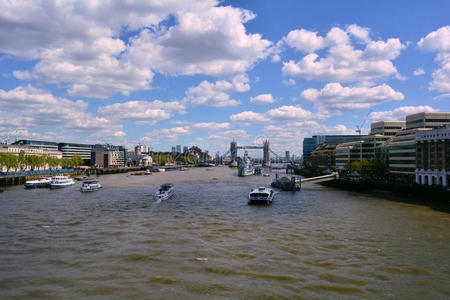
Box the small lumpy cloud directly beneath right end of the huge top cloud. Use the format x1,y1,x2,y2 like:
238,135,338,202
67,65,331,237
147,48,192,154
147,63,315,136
186,75,250,107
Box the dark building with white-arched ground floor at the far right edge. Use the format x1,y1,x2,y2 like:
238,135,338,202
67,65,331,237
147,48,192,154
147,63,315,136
415,125,450,187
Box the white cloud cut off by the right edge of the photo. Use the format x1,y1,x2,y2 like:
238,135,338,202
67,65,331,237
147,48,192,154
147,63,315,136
417,26,450,93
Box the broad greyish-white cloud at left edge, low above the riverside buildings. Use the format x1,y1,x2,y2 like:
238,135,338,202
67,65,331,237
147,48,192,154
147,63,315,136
0,86,123,137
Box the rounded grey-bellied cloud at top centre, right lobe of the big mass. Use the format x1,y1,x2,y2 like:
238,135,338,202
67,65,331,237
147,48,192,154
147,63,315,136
126,6,271,76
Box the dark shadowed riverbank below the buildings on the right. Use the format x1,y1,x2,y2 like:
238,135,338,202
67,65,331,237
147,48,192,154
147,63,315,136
319,179,450,213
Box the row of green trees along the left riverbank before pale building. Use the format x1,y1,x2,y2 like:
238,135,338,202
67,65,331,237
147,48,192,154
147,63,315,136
0,153,84,172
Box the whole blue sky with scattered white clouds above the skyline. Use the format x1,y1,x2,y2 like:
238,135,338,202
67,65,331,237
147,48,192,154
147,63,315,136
0,0,450,156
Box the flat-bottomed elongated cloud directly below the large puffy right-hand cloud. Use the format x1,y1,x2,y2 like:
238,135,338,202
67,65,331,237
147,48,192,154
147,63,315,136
301,83,404,114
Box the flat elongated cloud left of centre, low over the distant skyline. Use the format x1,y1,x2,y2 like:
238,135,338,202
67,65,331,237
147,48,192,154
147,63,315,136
98,100,186,125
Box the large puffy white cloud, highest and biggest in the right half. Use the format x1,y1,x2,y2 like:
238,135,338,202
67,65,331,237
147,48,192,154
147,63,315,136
282,25,406,82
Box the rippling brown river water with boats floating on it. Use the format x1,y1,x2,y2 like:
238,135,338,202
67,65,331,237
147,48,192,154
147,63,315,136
0,167,450,299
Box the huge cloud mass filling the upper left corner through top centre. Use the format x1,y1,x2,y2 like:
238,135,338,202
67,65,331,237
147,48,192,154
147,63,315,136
0,0,271,98
